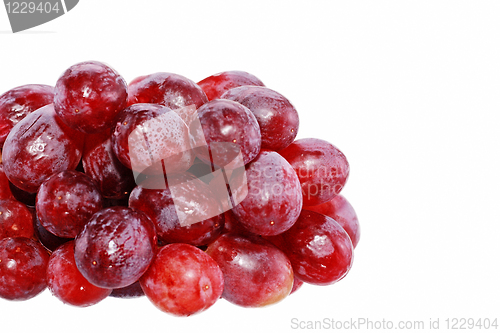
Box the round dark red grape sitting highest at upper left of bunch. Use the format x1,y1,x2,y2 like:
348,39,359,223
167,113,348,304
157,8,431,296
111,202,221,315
54,61,127,133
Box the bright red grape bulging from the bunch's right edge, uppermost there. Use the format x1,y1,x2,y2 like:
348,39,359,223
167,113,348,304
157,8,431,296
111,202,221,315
279,139,349,206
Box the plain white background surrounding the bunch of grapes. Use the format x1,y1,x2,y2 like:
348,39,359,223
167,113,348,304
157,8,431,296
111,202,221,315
0,0,500,333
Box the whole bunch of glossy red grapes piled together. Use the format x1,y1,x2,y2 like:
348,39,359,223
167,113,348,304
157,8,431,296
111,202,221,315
0,61,360,316
